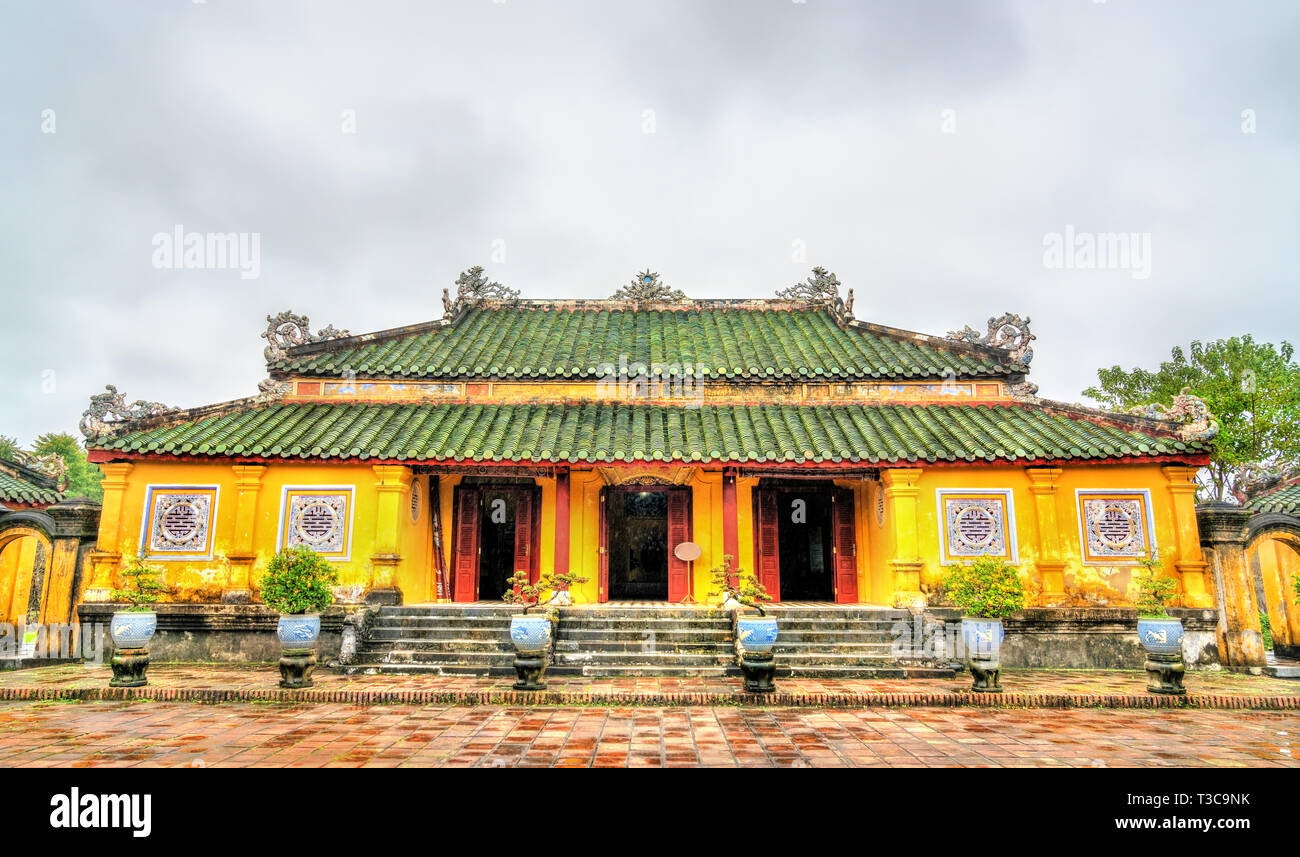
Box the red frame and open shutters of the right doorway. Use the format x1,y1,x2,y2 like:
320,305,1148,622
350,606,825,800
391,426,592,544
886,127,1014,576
753,480,858,603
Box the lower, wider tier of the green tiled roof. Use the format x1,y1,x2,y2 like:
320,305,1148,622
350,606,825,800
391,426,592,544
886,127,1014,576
91,403,1208,463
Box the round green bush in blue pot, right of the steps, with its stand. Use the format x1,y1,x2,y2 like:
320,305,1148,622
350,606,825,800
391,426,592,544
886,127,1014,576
944,557,1024,693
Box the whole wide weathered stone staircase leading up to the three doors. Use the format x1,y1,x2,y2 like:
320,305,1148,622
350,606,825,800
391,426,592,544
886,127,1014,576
339,603,953,679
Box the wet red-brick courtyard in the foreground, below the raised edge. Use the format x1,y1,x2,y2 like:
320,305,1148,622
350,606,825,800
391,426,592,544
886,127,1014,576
0,701,1300,767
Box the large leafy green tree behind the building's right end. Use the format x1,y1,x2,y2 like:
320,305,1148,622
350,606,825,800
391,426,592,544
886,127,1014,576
1083,334,1300,499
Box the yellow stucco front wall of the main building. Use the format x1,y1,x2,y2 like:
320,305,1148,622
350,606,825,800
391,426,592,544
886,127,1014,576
83,460,1200,613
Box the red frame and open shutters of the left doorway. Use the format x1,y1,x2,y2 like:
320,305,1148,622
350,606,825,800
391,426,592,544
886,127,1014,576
451,482,542,602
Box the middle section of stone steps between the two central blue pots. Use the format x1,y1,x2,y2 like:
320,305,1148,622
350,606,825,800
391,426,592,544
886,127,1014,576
547,605,740,678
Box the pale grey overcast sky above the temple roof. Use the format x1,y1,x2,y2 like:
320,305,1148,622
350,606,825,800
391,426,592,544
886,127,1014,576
0,0,1300,445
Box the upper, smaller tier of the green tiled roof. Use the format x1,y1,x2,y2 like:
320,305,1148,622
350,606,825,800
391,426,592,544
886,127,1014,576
272,304,1017,381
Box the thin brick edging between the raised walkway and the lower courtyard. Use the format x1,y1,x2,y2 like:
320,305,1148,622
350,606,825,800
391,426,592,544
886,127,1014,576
0,687,1300,711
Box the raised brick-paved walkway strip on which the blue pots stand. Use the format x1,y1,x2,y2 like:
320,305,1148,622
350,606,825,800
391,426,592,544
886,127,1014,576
0,663,1300,710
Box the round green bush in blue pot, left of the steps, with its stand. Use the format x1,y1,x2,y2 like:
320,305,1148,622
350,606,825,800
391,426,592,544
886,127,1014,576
261,545,338,689
